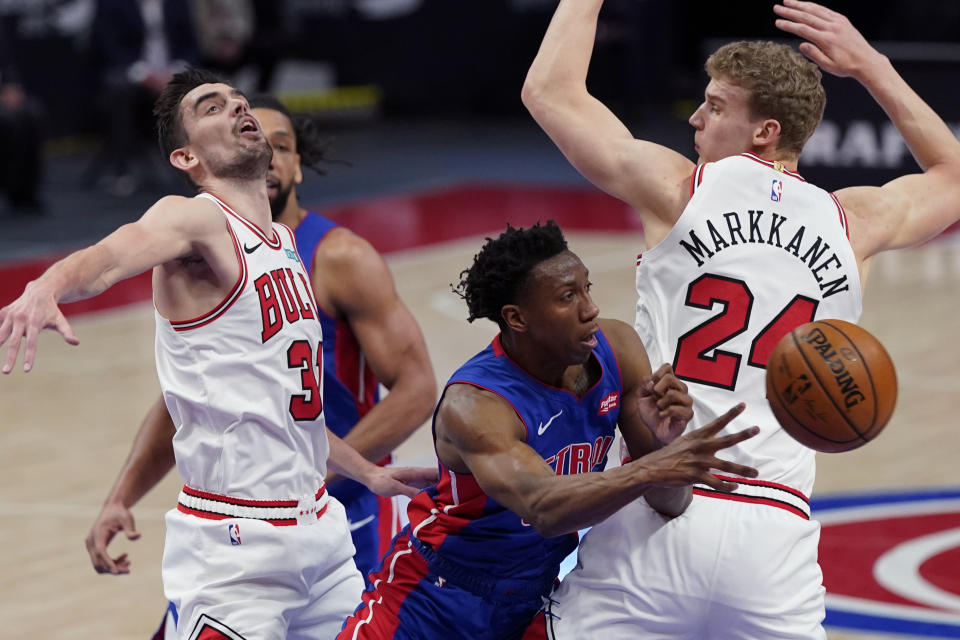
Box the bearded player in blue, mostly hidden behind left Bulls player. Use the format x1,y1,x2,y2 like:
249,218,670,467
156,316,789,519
87,95,436,640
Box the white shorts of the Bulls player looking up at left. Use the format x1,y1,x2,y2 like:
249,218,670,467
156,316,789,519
163,494,364,640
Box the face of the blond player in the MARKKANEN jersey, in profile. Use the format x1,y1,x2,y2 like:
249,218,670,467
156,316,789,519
689,78,764,163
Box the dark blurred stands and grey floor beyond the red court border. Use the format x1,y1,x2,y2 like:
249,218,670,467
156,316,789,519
0,0,960,254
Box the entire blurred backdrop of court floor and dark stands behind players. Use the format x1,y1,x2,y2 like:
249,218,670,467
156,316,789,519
0,0,960,640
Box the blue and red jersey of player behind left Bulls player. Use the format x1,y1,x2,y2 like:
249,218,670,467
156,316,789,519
294,211,380,504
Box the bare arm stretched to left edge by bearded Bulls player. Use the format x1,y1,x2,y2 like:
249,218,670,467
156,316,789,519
0,196,225,373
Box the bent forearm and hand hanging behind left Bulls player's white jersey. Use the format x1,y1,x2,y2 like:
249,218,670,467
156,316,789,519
86,398,176,574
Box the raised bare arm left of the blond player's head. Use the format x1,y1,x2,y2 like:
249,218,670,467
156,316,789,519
521,0,694,226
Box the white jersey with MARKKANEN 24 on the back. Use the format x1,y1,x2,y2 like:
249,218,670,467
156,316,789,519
635,154,861,496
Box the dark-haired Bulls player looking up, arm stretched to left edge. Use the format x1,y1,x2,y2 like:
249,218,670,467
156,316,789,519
0,69,434,638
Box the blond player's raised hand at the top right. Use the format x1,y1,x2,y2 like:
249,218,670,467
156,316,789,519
773,0,880,78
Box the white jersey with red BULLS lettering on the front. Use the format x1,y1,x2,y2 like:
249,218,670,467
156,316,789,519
156,194,329,506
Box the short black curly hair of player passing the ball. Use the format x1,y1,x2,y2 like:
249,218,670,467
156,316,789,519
453,220,567,329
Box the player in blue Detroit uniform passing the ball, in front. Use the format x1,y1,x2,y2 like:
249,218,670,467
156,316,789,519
338,221,756,640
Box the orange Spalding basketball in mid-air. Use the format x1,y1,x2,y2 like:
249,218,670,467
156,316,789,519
767,320,897,453
